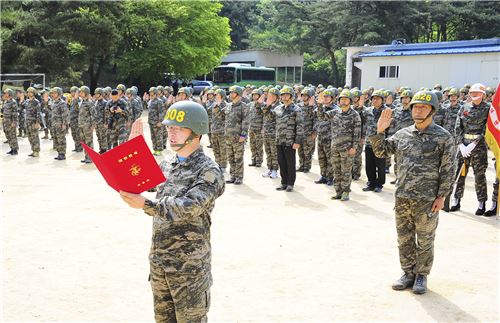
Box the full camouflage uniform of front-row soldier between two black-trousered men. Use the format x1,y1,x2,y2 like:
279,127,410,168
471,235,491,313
318,107,361,194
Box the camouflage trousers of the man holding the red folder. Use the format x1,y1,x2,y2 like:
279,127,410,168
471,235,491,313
149,263,210,323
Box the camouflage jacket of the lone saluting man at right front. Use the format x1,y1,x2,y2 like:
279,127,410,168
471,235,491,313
370,123,455,201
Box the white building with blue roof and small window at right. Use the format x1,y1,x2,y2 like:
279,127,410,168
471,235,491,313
345,38,500,89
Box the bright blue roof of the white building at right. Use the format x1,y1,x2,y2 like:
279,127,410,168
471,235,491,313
359,38,500,57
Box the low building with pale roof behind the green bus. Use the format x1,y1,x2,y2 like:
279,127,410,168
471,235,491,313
222,49,304,84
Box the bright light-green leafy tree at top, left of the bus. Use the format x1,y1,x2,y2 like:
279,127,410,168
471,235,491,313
116,0,230,83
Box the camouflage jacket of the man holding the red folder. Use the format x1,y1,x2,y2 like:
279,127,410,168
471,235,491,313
143,148,225,280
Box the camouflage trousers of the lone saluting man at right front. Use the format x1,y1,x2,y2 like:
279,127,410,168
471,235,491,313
394,197,439,275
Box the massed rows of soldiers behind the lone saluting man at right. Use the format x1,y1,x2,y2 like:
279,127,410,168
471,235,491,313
192,84,495,206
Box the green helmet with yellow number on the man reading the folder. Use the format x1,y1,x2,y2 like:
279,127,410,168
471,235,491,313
162,101,208,135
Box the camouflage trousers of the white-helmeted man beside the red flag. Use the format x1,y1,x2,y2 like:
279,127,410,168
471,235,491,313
455,140,488,202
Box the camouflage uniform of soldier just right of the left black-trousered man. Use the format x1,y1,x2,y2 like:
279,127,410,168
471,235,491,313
299,103,317,171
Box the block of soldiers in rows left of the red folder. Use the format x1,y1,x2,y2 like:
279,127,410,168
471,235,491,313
2,84,143,163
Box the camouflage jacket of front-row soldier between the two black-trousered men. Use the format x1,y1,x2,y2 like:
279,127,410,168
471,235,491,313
318,107,361,150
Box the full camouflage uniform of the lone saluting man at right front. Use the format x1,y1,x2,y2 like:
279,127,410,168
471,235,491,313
370,123,455,275
